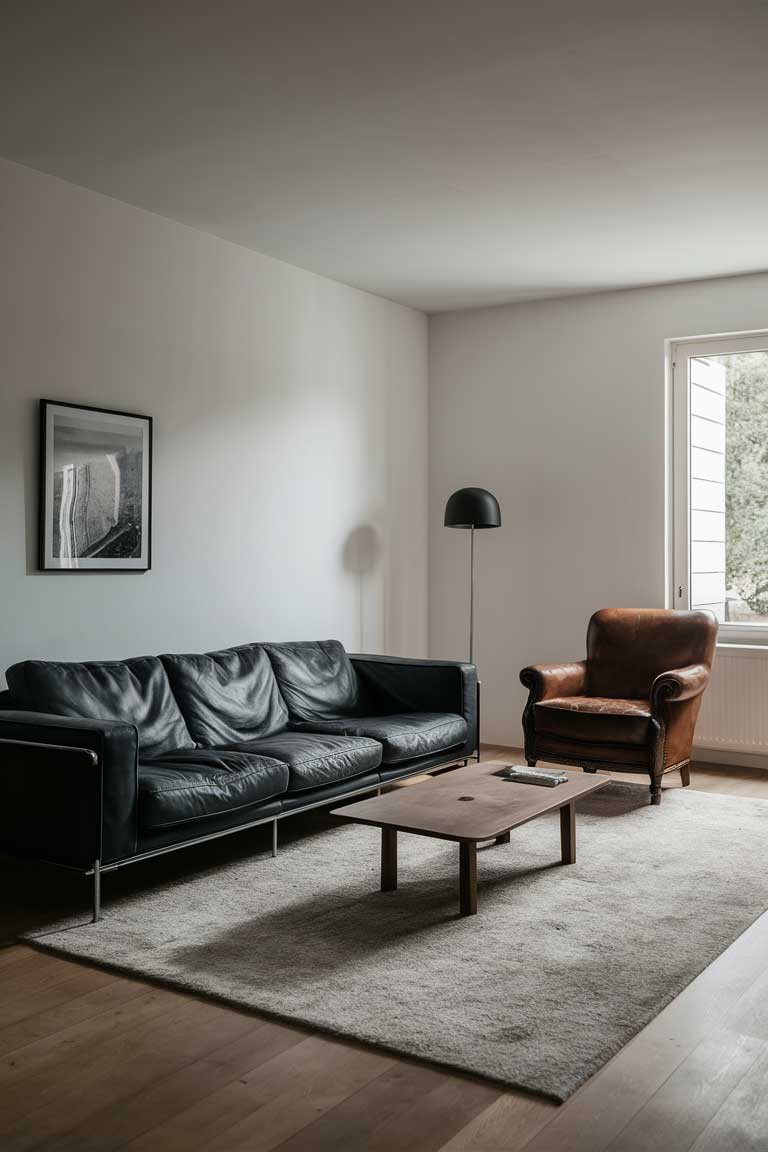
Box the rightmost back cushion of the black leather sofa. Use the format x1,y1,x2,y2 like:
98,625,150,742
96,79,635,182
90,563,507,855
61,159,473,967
264,641,360,721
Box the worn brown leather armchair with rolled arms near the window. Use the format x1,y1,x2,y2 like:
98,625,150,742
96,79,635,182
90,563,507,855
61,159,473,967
520,608,717,804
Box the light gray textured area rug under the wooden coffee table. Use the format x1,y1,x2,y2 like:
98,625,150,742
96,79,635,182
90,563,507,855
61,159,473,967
30,782,768,1100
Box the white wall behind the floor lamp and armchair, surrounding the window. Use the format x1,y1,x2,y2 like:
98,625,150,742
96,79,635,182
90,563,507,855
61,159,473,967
429,274,768,744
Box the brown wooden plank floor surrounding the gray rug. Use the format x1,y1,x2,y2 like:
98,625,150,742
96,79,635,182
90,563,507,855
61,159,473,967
0,749,768,1152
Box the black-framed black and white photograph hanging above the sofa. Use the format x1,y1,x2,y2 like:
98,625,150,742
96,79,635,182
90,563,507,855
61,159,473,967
39,400,152,571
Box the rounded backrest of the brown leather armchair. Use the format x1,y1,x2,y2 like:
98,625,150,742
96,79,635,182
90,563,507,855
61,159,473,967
587,608,717,699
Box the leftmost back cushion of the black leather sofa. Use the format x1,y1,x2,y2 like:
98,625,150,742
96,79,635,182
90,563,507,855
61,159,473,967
6,655,195,759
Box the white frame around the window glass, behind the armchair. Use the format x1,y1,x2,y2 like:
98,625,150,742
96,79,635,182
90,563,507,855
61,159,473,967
668,332,768,646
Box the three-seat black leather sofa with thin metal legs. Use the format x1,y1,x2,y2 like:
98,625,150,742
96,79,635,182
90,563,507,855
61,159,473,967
0,641,478,919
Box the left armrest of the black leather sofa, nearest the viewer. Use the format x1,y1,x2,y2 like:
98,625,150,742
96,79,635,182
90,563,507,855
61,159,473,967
0,710,138,866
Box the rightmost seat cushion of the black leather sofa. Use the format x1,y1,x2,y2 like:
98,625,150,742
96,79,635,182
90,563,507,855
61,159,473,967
291,712,466,764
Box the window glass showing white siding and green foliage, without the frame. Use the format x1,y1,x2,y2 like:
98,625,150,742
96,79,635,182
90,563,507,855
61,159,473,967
690,351,768,626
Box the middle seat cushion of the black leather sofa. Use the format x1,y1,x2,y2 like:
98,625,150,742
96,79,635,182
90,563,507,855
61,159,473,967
230,732,381,793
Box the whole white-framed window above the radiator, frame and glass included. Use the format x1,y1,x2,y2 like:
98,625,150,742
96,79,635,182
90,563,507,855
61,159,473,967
671,333,768,644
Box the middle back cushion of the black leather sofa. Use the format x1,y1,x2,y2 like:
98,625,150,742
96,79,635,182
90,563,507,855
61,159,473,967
160,644,288,748
